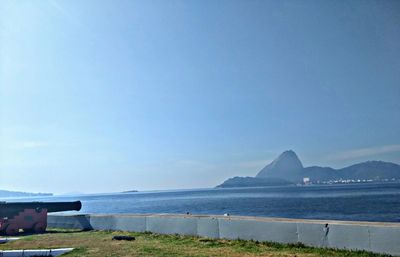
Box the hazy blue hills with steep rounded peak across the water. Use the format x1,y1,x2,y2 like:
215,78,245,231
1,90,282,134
218,150,400,187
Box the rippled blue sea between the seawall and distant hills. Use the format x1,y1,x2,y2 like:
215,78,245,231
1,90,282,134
0,183,400,222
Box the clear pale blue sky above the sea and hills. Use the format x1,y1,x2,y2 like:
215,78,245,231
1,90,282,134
0,0,400,194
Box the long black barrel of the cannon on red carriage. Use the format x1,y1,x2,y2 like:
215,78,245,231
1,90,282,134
0,201,82,217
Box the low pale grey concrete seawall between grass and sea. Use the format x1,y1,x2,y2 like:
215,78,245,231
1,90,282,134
48,215,400,256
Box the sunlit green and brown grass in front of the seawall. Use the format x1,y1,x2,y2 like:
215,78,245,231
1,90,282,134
0,229,388,257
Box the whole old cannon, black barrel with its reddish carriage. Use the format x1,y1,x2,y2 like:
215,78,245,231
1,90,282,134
0,201,82,235
